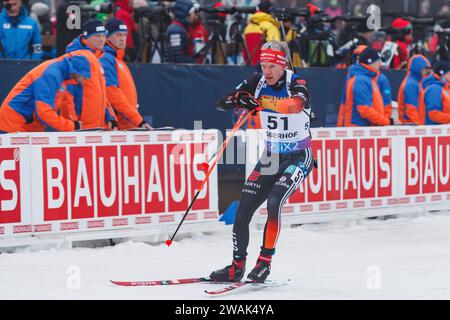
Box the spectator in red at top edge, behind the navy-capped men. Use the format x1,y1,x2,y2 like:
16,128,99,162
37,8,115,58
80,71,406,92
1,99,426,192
115,0,138,61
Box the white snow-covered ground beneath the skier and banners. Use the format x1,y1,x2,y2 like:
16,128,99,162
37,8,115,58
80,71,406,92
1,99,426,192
0,213,450,300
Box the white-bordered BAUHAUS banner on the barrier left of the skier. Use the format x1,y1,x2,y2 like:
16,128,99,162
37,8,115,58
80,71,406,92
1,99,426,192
0,130,218,245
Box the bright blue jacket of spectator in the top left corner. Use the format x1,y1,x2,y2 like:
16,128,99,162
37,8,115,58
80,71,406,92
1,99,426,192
0,7,42,60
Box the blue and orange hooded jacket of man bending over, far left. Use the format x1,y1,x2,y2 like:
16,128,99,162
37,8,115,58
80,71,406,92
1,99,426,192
0,52,92,132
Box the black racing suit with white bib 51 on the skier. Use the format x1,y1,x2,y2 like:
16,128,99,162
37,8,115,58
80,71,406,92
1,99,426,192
217,71,314,260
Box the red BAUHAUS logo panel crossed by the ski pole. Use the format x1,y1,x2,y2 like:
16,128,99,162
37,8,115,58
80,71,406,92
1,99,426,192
39,143,210,222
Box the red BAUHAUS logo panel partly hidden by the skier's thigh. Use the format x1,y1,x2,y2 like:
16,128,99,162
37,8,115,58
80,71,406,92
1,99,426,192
289,138,393,205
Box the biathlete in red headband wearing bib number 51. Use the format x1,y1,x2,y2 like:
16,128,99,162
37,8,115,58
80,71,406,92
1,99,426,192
210,41,314,282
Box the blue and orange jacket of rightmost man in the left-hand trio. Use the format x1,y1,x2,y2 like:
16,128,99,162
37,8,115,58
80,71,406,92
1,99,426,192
100,42,143,129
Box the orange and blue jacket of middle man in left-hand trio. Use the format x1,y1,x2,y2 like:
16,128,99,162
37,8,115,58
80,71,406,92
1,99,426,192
56,35,115,129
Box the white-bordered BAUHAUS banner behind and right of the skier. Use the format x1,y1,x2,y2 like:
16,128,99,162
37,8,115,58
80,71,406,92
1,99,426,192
246,126,450,222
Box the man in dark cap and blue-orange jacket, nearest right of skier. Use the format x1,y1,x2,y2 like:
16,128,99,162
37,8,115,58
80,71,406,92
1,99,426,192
343,48,390,127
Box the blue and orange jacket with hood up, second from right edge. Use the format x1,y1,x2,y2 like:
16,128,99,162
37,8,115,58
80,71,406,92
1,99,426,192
397,55,431,124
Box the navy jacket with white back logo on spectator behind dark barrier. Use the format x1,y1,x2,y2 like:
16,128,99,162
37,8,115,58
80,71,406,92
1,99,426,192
166,20,195,63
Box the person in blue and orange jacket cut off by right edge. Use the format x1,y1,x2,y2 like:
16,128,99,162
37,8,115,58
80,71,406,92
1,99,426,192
419,60,450,124
